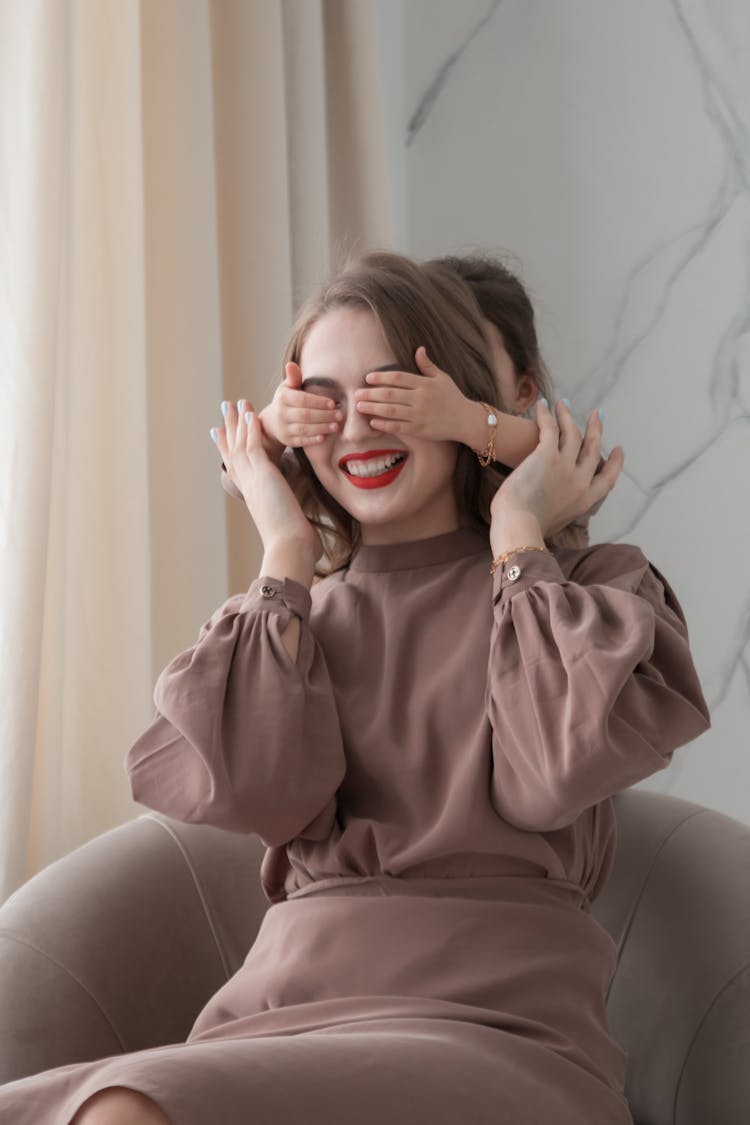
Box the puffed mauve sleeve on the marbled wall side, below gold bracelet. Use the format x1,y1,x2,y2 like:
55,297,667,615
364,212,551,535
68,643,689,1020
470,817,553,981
486,543,711,831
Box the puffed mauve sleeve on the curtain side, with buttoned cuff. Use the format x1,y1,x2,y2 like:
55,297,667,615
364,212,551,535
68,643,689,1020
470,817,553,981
125,577,345,846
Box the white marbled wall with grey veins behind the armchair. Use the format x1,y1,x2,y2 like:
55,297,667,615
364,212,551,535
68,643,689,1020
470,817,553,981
381,0,750,822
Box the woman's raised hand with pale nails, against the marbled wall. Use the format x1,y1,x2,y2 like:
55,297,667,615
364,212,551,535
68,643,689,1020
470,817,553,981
490,398,625,538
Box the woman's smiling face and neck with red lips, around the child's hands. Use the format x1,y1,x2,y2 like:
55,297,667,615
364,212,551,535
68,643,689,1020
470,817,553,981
299,308,460,545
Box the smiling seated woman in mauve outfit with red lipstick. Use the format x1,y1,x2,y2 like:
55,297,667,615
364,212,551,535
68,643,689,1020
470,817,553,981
0,254,710,1125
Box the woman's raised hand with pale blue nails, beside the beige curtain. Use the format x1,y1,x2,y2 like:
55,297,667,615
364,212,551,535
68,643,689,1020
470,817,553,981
211,398,323,561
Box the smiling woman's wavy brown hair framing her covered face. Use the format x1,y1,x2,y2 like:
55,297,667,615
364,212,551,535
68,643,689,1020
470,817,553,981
283,251,580,578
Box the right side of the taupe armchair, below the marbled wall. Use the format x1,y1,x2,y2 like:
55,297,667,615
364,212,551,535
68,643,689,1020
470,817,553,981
591,789,750,1125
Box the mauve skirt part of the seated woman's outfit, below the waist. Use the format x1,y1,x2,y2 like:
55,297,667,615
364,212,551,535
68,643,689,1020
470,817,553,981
0,875,632,1125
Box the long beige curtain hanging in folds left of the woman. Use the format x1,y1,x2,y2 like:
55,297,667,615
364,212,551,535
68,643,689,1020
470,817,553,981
0,0,394,898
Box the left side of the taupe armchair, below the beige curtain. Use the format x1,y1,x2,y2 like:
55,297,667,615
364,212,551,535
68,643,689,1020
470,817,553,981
0,813,268,1082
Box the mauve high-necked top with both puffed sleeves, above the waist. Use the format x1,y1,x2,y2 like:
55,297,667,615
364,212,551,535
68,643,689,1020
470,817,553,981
126,528,711,902
